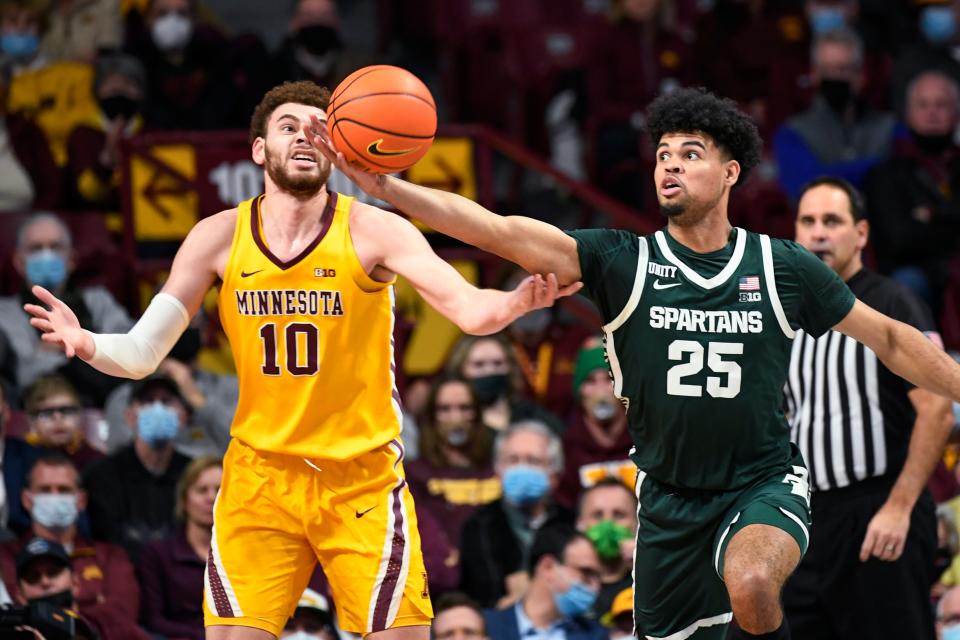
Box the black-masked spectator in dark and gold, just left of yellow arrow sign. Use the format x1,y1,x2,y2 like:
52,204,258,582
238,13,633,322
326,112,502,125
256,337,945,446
66,53,146,212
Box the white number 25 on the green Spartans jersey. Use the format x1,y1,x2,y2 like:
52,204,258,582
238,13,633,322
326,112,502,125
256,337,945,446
667,340,743,398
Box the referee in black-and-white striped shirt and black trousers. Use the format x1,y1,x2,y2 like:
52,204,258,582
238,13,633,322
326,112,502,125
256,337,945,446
783,177,953,640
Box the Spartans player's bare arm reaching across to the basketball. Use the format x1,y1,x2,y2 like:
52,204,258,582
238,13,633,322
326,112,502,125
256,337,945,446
304,118,580,284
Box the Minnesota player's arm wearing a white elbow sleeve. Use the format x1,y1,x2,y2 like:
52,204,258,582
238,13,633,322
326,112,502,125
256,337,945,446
24,214,232,378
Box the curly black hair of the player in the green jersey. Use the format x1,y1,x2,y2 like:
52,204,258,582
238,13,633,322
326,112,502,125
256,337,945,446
647,87,763,187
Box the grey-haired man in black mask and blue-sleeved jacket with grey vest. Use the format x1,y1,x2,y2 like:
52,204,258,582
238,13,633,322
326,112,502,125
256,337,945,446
773,29,897,201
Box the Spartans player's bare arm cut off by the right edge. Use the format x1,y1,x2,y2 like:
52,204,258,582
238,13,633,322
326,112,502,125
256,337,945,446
834,300,960,402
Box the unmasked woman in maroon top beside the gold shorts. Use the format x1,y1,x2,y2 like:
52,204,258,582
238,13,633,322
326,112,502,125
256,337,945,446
139,458,223,640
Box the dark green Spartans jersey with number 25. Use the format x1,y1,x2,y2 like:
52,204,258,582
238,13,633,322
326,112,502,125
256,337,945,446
570,228,854,490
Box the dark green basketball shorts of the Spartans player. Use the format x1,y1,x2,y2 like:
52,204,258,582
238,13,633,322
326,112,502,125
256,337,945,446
633,445,810,640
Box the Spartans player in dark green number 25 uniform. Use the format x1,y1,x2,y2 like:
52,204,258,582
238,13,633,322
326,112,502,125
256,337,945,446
312,89,960,640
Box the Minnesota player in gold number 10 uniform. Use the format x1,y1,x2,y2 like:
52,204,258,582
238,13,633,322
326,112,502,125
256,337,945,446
27,82,579,640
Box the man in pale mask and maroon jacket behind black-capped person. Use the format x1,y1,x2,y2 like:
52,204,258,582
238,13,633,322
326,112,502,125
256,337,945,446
0,452,140,632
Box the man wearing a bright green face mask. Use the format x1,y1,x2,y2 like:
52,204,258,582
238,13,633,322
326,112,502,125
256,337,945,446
577,478,637,617
